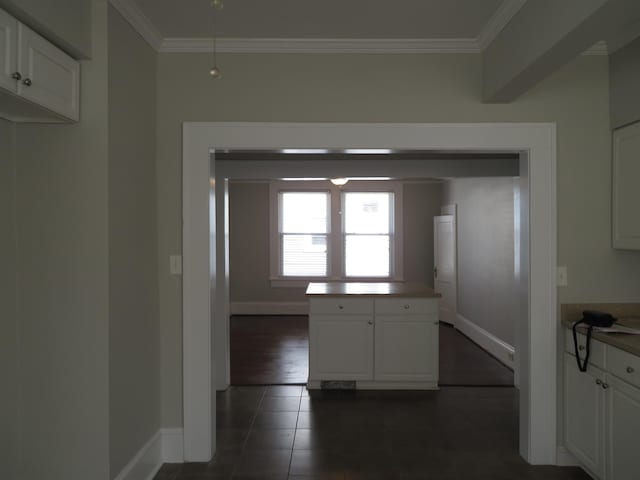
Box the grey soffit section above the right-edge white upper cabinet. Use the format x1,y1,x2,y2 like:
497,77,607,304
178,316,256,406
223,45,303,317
609,38,640,129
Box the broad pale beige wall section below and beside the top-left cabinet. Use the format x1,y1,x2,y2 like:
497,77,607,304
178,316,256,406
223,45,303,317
10,1,109,480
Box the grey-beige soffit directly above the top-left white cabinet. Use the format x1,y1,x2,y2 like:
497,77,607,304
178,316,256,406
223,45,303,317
0,0,93,58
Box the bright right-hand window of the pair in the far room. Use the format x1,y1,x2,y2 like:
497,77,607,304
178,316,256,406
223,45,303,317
343,192,393,277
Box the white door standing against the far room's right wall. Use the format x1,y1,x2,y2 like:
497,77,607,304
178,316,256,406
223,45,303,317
433,215,457,325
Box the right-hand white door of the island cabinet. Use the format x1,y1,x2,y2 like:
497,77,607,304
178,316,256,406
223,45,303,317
374,314,438,382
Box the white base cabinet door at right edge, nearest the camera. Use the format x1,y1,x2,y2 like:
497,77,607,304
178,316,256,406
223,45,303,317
607,375,640,480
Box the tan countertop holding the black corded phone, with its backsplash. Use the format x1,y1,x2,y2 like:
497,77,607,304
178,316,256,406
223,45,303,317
561,303,640,357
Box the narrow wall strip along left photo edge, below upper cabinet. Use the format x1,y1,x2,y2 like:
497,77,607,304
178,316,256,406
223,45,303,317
0,120,20,478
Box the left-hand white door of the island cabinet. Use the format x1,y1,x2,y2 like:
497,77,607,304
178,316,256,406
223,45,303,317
309,315,373,380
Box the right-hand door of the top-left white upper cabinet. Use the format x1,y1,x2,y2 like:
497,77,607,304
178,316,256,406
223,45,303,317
18,24,80,120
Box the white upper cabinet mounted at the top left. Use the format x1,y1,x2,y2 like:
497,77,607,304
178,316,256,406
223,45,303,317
0,10,80,122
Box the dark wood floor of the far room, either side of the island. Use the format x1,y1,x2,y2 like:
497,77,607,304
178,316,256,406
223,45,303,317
231,315,513,386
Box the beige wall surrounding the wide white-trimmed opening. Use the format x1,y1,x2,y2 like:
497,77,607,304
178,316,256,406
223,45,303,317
157,54,640,427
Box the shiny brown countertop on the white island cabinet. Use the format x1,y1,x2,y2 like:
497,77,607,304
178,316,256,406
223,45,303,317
307,282,440,298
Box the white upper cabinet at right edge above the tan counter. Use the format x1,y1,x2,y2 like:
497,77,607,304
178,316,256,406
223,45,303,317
612,122,640,250
